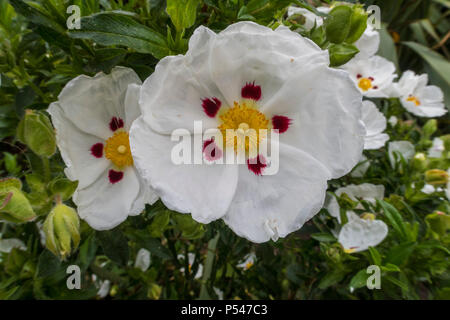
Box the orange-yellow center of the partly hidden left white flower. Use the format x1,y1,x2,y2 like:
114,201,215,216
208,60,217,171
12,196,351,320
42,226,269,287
105,131,133,168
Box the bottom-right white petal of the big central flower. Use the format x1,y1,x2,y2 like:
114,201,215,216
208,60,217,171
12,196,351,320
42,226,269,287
223,145,330,243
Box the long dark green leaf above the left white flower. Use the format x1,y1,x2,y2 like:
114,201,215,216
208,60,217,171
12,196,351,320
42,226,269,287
69,12,170,59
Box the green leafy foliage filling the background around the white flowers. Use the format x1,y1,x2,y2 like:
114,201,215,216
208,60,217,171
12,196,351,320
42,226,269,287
0,0,450,299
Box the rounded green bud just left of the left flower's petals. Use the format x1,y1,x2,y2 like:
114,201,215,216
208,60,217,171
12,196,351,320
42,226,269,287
17,110,56,157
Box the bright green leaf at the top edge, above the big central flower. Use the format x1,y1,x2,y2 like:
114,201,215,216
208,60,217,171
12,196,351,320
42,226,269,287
166,0,200,32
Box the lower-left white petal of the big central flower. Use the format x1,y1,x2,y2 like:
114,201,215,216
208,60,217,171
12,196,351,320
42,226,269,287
130,118,237,223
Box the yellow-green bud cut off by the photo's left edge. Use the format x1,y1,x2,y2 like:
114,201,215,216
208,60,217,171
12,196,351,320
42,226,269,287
0,178,36,223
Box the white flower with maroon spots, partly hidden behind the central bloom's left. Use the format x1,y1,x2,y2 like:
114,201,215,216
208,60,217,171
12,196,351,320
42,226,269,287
48,67,157,230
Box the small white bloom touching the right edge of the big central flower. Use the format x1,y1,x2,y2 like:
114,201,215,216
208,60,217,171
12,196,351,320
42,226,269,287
362,101,389,150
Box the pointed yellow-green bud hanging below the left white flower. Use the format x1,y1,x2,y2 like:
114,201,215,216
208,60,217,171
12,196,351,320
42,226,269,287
44,204,80,260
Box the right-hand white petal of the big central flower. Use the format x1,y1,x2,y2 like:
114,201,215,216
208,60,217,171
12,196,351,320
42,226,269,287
263,65,365,178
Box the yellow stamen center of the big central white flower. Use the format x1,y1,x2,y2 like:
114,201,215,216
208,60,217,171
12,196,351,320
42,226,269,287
218,101,269,152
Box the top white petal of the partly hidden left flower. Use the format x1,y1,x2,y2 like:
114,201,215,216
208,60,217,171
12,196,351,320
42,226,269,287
50,67,141,140
